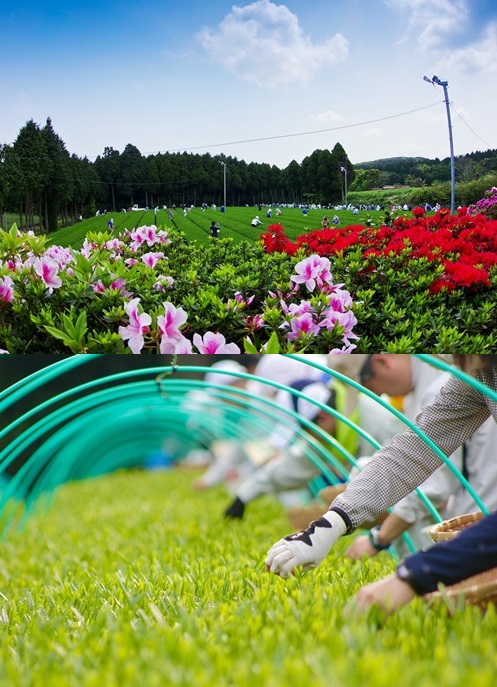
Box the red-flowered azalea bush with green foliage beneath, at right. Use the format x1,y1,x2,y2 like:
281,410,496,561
262,199,497,353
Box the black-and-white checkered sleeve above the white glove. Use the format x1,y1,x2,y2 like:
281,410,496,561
330,370,497,533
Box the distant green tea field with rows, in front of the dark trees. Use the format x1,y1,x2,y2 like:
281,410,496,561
49,207,384,249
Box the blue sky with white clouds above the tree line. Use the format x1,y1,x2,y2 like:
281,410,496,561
0,0,497,168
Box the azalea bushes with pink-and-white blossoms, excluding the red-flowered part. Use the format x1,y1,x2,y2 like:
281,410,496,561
0,226,357,354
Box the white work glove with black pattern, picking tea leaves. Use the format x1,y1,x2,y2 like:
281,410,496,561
265,510,347,578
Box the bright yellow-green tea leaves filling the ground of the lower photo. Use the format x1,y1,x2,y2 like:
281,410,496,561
0,470,497,687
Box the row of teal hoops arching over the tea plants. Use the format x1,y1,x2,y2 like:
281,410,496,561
0,355,490,546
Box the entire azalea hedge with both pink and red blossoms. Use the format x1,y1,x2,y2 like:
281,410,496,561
0,194,497,354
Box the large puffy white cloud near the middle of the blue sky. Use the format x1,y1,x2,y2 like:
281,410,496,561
197,0,349,87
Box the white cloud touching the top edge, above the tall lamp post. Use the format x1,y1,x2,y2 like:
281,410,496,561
385,0,469,51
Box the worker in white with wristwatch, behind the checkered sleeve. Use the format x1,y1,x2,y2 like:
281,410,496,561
347,353,463,559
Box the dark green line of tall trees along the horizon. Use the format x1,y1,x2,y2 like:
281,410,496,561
0,118,497,233
